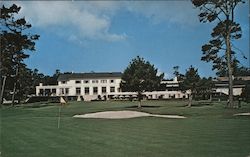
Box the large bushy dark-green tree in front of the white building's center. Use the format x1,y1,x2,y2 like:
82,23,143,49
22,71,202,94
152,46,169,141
121,56,164,108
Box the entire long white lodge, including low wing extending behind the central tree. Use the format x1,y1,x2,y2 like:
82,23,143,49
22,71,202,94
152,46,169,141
36,72,188,101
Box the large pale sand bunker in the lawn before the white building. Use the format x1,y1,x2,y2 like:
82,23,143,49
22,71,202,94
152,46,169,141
73,111,186,119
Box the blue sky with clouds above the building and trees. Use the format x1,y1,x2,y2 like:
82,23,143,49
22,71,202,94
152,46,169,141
4,1,250,78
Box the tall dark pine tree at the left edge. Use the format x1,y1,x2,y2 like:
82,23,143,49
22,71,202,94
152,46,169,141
0,4,39,102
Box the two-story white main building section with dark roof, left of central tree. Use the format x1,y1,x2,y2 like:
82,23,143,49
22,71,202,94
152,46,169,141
36,72,122,100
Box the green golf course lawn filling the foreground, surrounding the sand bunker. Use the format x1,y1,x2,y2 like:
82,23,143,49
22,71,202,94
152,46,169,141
0,101,250,157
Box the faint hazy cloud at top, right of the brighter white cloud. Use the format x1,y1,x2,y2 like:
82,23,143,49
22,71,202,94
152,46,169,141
127,1,199,26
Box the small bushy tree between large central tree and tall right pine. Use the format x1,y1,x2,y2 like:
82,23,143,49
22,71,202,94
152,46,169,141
180,66,200,107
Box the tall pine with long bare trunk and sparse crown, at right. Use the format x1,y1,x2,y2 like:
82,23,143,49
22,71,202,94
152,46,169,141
192,0,244,107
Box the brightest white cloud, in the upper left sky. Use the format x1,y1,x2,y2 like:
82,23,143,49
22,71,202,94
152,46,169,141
13,1,126,41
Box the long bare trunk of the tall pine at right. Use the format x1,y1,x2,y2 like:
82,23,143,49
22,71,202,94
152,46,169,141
226,31,234,108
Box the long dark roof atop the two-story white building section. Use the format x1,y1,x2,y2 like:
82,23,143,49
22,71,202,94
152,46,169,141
57,72,122,81
